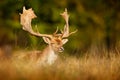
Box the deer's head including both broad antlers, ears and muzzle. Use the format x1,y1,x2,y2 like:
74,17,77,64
20,7,77,52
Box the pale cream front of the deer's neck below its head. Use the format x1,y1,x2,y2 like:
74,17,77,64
42,45,57,65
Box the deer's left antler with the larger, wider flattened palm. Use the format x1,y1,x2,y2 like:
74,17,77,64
20,7,52,38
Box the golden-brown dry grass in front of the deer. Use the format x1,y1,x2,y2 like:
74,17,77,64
0,51,120,80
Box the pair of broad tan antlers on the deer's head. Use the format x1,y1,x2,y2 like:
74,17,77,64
20,7,77,39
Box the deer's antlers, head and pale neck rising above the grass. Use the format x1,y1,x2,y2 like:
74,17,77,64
20,7,77,65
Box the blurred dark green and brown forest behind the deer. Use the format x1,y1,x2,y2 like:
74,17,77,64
0,0,120,54
